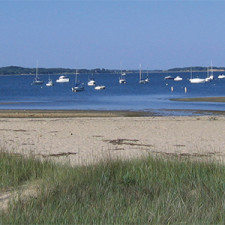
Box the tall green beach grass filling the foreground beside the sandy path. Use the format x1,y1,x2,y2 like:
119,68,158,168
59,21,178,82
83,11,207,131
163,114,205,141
0,152,225,225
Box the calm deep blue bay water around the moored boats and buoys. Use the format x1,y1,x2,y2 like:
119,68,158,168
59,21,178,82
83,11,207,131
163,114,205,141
0,73,225,114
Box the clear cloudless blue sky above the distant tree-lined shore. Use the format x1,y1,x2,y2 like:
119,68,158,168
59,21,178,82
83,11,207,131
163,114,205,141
0,0,225,69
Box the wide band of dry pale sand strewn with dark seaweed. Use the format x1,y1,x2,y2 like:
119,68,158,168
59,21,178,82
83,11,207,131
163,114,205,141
0,110,225,165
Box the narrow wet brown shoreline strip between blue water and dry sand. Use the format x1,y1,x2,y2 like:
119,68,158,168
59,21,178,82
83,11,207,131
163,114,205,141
0,109,225,118
